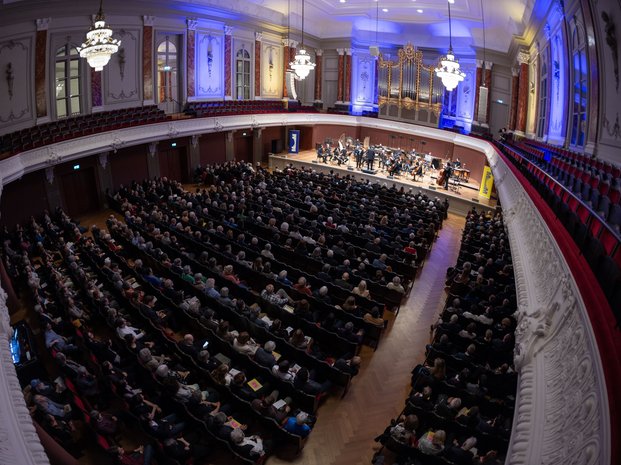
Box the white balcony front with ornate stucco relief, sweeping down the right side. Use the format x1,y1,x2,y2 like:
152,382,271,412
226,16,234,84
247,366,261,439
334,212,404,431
489,148,610,465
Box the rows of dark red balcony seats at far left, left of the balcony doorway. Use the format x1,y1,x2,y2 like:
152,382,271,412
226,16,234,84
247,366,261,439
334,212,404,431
0,105,168,160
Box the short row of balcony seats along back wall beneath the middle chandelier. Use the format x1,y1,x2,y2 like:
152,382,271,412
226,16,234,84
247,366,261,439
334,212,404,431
184,100,317,118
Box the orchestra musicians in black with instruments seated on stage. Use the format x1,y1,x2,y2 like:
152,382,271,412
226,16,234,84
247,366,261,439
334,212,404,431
316,135,470,189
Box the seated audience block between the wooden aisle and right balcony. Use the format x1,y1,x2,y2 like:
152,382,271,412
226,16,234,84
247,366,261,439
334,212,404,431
376,210,517,465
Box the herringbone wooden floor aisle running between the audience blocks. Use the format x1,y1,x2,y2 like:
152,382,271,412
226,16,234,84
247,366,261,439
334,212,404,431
267,214,465,465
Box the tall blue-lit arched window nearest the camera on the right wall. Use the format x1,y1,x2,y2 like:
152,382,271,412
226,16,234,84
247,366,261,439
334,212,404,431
570,16,589,148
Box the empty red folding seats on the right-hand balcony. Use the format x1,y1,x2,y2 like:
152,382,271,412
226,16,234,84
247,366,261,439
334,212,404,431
498,140,621,325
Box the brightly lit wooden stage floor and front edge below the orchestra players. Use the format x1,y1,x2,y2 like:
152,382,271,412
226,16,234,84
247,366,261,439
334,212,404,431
269,150,496,214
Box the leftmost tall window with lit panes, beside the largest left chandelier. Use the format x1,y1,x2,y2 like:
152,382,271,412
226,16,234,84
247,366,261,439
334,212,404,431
54,44,82,118
